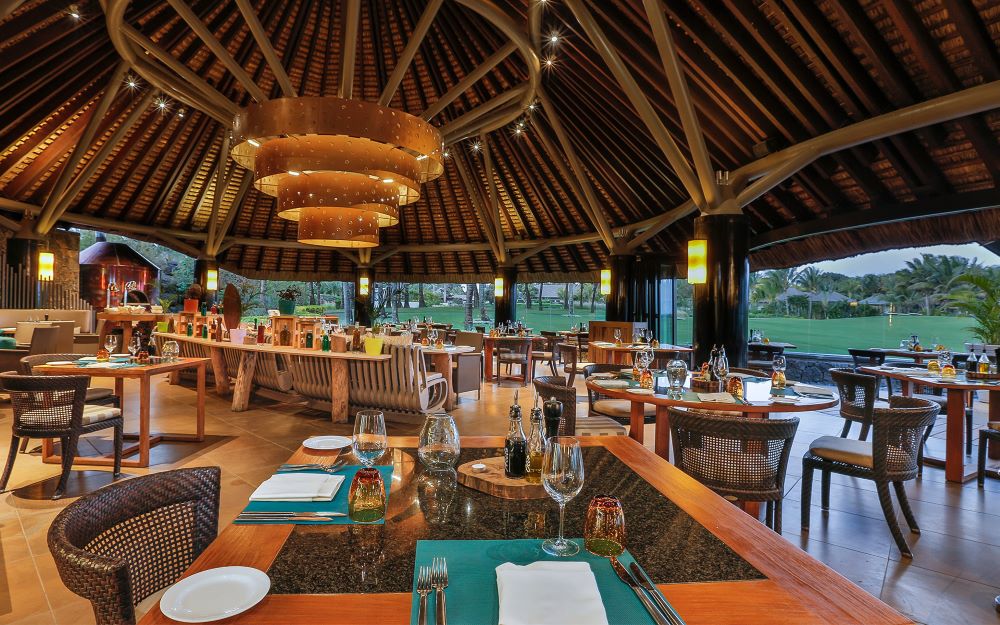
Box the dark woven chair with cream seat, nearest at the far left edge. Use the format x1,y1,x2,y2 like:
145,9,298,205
0,373,123,499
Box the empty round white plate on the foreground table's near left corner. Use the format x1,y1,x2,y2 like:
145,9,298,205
160,566,271,623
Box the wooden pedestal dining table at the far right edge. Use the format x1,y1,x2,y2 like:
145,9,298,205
858,365,1000,483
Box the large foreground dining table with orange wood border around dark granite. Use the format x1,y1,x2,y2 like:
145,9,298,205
139,436,911,625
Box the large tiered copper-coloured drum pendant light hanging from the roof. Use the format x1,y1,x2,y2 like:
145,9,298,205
231,96,444,247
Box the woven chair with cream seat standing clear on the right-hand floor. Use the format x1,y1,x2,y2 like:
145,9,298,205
802,397,938,558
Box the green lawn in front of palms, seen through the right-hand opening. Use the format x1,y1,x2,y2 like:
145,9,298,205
677,315,973,354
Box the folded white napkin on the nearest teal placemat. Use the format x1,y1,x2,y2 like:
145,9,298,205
497,562,608,625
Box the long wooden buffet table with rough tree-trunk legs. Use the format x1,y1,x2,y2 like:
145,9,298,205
157,332,392,423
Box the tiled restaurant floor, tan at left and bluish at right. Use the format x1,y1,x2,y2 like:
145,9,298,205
0,372,1000,625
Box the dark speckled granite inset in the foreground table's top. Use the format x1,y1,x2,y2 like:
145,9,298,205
268,447,764,594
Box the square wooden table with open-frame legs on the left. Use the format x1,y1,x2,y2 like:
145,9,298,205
32,358,208,468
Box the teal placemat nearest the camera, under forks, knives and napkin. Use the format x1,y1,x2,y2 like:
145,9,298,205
410,538,654,625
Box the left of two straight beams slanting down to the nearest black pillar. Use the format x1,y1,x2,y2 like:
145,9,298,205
566,0,706,208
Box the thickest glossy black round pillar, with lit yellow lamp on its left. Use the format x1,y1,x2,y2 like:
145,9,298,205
694,214,750,367
